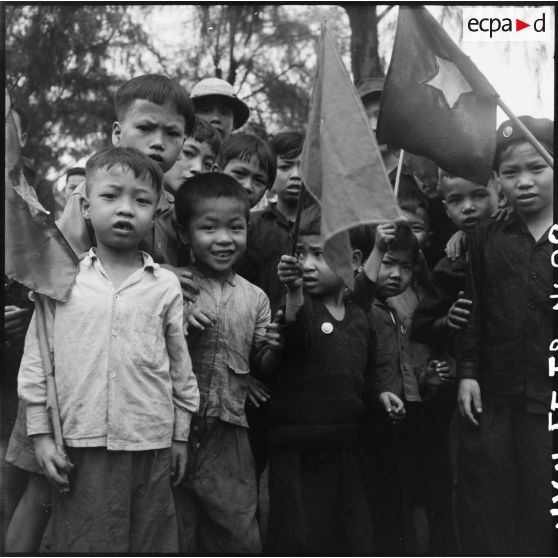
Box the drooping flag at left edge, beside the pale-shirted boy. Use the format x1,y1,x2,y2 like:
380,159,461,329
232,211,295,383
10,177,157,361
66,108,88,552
4,92,79,301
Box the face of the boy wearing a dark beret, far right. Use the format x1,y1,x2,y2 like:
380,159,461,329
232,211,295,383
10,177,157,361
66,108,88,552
498,142,554,216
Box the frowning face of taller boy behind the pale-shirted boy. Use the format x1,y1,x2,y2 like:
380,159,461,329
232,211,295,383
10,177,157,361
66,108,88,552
112,99,185,172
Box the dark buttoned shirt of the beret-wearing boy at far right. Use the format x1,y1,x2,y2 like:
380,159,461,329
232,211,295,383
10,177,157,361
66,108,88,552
457,213,552,413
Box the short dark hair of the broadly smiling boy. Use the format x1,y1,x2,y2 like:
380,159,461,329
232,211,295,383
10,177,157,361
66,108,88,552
174,172,250,227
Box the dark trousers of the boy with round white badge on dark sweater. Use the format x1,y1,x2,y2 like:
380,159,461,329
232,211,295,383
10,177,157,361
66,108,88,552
268,449,373,556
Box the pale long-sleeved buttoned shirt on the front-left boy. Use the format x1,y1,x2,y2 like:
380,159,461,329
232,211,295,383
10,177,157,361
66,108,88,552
18,249,199,451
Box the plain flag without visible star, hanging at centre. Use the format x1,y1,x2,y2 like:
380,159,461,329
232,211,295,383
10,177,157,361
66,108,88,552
300,25,401,287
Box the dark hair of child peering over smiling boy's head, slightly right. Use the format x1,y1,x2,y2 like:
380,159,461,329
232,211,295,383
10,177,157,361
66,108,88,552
217,133,277,189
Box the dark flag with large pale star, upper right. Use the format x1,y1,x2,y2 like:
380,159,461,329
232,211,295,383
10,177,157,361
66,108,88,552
377,7,498,184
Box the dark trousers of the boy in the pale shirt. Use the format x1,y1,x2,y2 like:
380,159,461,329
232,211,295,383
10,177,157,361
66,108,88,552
52,448,178,554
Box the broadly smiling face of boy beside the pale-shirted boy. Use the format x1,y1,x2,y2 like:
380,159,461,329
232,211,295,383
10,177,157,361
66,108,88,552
185,198,248,276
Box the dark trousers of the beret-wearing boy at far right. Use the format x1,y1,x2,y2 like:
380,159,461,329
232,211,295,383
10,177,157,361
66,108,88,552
457,402,556,556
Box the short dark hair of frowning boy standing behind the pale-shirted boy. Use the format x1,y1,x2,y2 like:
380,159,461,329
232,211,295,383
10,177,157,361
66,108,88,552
114,74,195,136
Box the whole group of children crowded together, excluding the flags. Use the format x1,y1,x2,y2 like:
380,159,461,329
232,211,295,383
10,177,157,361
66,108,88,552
6,75,553,555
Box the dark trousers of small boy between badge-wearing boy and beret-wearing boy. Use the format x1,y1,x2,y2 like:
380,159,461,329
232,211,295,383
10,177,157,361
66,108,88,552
359,403,456,556
